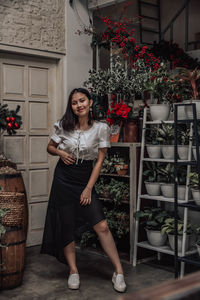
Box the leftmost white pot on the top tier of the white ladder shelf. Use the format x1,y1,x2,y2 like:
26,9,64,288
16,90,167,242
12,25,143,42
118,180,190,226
150,104,170,121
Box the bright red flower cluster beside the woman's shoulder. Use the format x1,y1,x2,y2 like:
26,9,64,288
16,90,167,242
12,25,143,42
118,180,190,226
106,101,131,125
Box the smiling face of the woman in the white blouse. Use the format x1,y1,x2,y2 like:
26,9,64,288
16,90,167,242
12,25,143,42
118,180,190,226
71,93,93,118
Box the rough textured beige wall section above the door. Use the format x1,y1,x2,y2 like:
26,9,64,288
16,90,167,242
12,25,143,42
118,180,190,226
0,0,66,52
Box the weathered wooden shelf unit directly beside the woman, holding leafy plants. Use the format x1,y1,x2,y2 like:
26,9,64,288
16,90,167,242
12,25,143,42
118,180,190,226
100,142,140,263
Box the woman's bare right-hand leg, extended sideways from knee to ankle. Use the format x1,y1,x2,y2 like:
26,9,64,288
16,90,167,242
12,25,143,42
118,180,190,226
93,220,123,274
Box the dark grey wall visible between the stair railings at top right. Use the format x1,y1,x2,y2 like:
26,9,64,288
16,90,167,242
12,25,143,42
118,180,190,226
161,0,200,47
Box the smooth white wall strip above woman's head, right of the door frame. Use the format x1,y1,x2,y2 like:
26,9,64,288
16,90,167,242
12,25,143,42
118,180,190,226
63,0,92,109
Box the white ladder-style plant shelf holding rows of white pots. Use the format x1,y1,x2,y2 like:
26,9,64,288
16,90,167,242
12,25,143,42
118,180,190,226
133,104,197,273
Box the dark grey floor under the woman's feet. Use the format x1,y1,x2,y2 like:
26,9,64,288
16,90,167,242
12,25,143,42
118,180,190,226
0,247,174,300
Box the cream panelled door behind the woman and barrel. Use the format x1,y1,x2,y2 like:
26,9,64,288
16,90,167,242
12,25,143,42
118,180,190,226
0,54,57,245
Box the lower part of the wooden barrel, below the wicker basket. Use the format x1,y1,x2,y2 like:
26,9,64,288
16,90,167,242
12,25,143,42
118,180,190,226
0,227,26,289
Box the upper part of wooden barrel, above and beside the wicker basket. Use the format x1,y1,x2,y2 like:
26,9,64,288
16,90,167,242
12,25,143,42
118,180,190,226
0,172,28,237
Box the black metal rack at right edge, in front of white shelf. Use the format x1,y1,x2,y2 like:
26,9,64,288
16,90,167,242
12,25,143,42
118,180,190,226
174,103,200,278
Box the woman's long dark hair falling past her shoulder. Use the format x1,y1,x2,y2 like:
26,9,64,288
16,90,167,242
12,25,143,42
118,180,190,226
60,88,92,131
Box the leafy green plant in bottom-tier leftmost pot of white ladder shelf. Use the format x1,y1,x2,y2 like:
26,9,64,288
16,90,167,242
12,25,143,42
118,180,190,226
134,207,170,230
